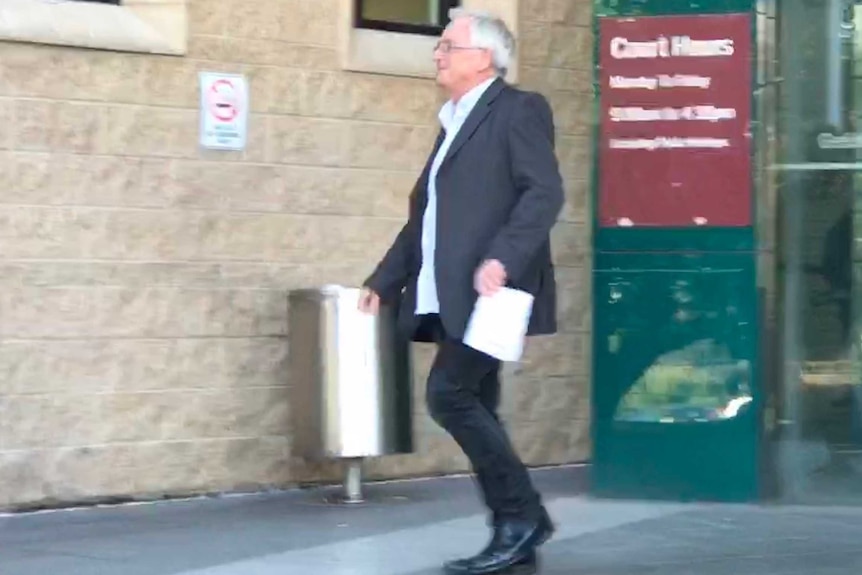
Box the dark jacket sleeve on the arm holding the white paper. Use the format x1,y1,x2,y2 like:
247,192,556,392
486,93,564,281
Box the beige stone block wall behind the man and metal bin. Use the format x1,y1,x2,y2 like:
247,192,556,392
0,0,592,509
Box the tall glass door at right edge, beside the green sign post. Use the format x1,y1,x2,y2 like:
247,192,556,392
767,0,862,503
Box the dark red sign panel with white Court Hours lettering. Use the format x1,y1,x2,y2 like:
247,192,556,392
599,14,752,227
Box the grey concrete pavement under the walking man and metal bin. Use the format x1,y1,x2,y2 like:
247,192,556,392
0,468,862,575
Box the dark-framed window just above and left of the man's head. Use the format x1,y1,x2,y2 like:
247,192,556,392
356,0,461,36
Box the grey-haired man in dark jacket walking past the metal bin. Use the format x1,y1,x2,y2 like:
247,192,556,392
359,10,563,575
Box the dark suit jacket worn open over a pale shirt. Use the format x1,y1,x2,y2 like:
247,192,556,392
365,79,563,341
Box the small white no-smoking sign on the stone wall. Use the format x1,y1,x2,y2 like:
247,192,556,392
200,72,248,150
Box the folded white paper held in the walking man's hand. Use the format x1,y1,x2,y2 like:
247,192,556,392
464,288,533,361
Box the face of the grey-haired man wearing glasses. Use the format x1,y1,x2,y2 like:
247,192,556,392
434,18,491,91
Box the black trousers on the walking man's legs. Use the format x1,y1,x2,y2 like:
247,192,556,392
422,316,542,522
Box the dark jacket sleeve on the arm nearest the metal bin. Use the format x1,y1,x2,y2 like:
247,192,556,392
363,182,421,301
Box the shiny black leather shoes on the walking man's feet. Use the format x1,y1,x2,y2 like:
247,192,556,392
444,513,554,575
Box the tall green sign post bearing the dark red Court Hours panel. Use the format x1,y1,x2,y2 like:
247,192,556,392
592,0,762,501
